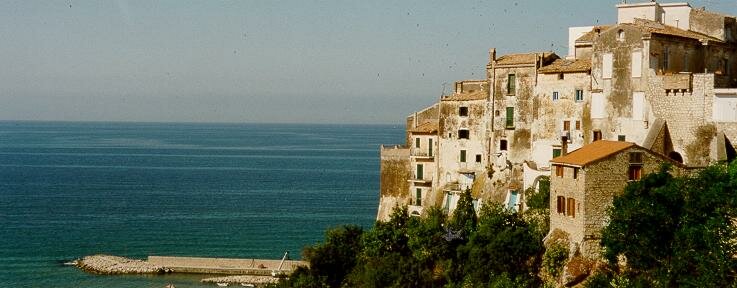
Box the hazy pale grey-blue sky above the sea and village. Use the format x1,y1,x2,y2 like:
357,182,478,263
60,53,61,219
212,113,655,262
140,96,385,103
0,0,737,124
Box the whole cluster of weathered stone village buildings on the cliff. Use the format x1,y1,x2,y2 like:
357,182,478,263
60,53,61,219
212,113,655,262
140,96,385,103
377,1,737,258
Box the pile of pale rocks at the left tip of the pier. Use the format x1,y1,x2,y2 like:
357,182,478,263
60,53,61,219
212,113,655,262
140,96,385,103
75,255,172,274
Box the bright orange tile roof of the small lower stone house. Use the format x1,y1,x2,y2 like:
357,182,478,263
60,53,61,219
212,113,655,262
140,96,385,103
550,140,635,166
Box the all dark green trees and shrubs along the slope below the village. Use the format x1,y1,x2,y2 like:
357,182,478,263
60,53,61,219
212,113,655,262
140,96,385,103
276,162,737,287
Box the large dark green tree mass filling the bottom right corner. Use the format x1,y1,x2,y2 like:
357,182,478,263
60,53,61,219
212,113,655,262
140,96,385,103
602,162,737,287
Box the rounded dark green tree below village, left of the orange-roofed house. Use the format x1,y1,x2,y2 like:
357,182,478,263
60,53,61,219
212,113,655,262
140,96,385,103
459,204,543,286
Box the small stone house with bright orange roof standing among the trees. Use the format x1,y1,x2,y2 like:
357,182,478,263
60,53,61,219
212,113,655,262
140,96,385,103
550,140,689,259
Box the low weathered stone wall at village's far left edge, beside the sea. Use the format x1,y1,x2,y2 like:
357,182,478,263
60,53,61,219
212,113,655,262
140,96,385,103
376,146,411,221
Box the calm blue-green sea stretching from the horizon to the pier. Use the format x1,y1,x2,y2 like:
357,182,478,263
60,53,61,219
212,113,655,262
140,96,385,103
0,121,404,288
